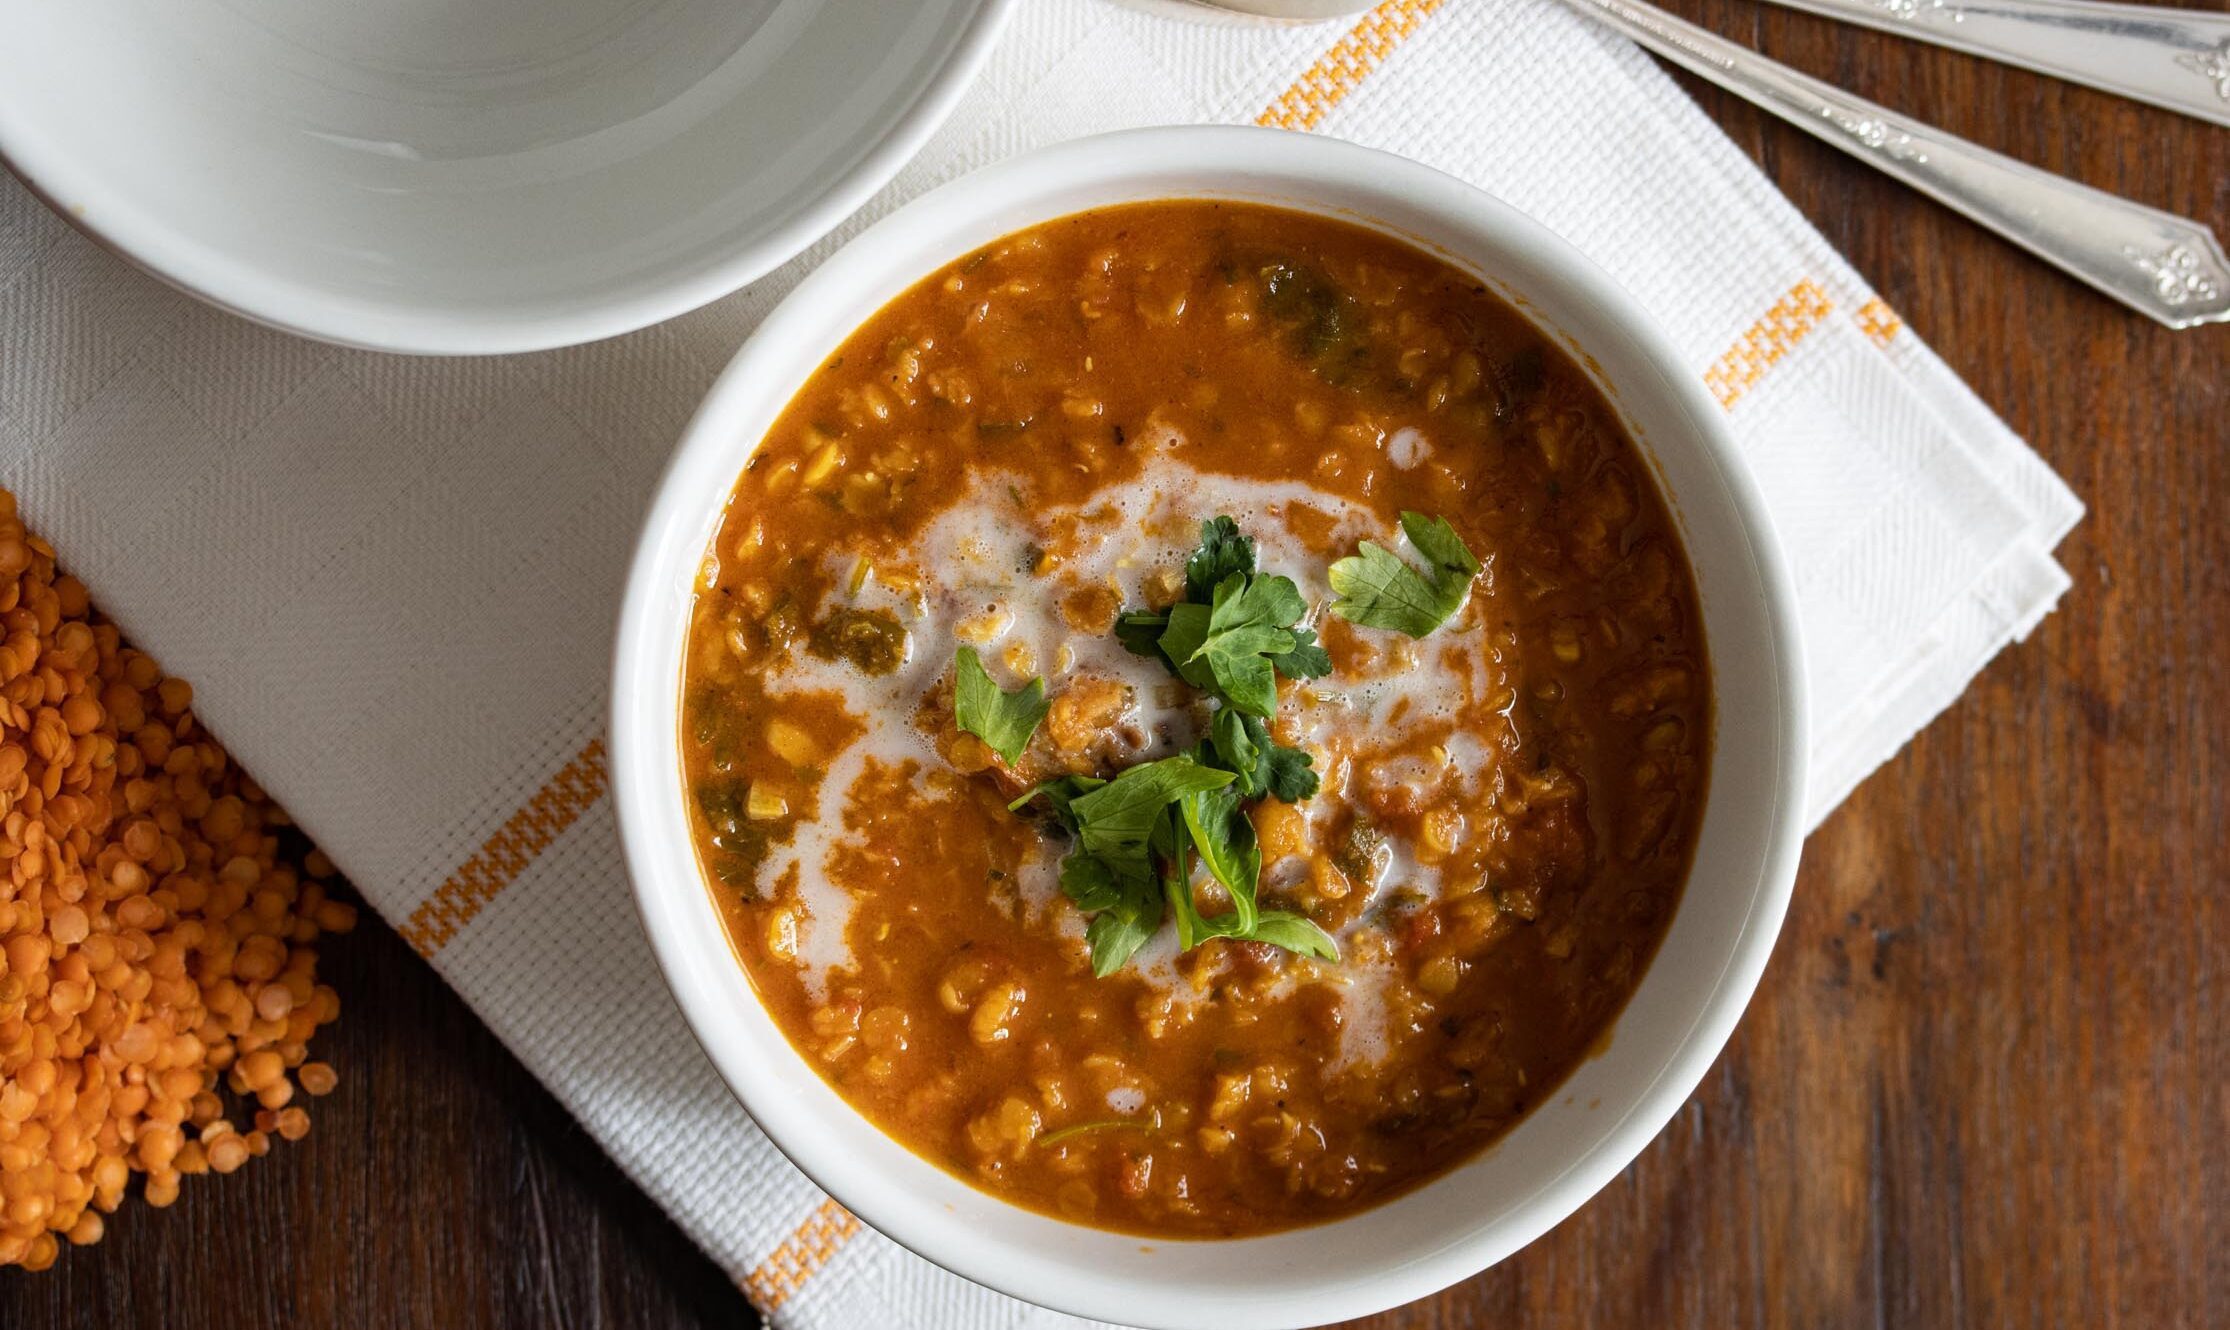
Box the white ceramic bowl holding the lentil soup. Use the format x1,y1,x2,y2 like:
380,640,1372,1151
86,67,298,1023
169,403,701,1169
611,127,1804,1330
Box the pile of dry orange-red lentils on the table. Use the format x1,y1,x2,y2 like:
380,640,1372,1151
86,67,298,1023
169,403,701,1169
0,491,357,1270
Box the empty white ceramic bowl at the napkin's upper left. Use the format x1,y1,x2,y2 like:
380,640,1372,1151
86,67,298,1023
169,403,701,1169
0,0,1010,355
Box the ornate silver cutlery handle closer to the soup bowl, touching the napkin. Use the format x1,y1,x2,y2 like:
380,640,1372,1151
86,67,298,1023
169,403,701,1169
1565,0,2230,328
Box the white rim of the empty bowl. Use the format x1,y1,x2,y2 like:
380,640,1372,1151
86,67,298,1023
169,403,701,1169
0,0,1017,355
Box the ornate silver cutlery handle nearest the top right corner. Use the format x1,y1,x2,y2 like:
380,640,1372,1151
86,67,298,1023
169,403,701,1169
1775,0,2230,125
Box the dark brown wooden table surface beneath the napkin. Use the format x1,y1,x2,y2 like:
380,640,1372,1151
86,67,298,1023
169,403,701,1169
0,0,2230,1330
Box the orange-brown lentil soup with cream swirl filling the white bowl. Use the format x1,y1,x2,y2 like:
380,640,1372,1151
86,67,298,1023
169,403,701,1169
680,203,1710,1236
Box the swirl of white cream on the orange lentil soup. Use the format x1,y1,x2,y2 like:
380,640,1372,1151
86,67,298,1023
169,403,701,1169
763,453,1494,1004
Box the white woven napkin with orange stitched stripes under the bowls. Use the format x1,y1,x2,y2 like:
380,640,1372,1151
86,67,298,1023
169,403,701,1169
0,0,2081,1330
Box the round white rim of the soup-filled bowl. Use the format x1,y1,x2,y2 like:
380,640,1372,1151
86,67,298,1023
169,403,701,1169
611,125,1809,1330
